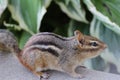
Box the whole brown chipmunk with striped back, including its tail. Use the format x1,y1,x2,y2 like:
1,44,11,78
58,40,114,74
0,30,106,78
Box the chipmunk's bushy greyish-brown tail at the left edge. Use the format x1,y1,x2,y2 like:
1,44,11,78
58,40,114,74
0,29,21,56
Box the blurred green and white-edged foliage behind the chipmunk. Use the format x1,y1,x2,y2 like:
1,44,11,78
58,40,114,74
0,0,120,72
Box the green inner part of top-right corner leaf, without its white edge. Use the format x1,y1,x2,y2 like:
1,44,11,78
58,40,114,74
91,0,120,26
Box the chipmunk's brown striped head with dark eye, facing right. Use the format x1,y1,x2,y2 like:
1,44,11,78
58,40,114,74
74,30,107,58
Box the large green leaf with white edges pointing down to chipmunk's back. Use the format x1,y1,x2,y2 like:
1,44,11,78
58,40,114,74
8,0,49,34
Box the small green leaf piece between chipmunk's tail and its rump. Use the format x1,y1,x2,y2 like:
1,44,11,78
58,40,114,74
19,31,32,49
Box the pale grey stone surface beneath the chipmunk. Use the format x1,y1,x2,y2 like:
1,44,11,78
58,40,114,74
0,53,120,80
